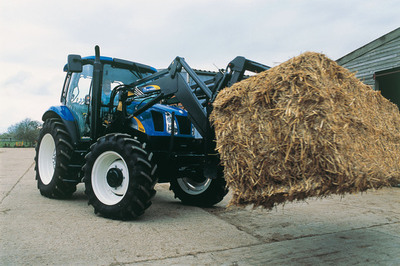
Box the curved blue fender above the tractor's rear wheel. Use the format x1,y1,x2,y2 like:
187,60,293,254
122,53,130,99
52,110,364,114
42,106,79,145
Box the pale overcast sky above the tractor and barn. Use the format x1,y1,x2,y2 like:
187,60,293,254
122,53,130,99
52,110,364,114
0,0,400,133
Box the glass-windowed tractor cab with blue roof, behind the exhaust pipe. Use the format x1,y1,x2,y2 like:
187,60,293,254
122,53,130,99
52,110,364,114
61,56,157,140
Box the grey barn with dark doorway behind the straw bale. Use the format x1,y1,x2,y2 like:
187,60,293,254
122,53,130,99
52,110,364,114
337,28,400,107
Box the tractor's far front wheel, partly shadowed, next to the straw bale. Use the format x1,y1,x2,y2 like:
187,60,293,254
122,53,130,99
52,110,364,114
170,172,228,207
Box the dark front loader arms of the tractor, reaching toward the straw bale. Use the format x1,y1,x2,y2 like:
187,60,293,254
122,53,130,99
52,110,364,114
131,56,270,138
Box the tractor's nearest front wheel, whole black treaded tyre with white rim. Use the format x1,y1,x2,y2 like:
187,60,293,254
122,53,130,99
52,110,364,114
84,134,157,220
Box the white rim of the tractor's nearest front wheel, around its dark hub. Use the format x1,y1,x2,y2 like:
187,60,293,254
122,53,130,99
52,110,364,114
91,151,129,205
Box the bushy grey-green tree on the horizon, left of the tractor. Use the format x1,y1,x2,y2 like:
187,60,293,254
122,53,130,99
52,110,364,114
8,118,42,142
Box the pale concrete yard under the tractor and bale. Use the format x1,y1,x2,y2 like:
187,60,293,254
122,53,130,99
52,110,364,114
0,149,400,265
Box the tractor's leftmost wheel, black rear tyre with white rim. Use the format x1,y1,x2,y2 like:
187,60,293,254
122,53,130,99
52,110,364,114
35,118,76,198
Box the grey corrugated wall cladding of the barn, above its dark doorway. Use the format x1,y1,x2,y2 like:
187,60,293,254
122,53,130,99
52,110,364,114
338,30,400,88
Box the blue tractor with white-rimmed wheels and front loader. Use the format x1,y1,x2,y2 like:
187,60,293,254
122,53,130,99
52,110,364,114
35,46,269,220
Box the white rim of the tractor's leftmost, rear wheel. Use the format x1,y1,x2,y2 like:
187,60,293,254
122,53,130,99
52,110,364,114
38,133,57,185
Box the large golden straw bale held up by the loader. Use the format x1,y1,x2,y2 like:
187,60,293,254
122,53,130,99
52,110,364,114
210,52,400,208
